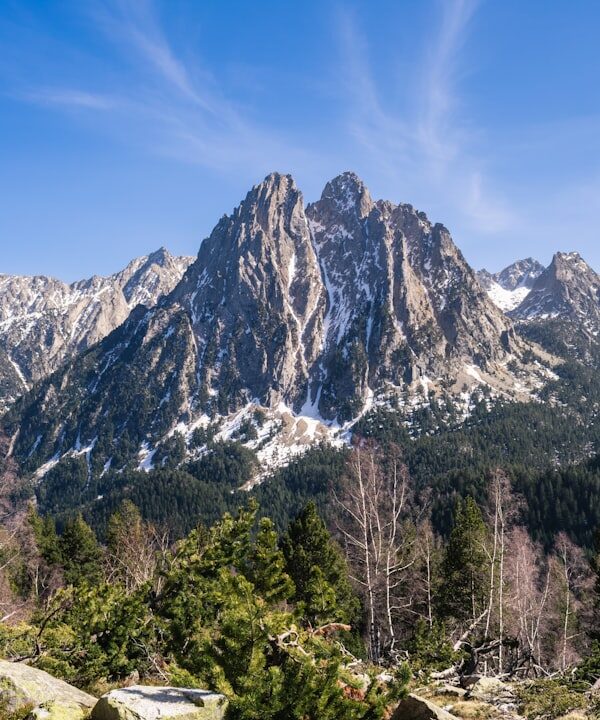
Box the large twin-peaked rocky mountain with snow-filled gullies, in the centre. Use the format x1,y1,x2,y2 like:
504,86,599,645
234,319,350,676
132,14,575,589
0,173,546,475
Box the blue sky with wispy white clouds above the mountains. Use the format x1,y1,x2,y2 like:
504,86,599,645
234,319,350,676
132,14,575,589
0,0,600,280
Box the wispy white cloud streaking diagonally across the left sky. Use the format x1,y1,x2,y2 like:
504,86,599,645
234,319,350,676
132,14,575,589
19,0,319,177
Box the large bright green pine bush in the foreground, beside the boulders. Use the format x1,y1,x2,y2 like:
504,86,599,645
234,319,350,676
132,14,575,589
156,504,404,720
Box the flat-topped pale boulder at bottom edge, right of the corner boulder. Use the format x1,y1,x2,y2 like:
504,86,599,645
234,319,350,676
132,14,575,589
92,685,227,720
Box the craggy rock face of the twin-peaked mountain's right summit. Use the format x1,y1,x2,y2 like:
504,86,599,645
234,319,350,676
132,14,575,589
307,173,511,417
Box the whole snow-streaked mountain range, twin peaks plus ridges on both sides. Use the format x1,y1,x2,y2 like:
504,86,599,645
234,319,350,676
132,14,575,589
0,173,600,477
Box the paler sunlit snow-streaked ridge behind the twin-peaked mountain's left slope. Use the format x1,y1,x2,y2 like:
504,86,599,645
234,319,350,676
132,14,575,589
0,248,191,410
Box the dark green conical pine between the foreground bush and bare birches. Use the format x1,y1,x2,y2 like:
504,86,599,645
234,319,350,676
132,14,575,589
282,502,360,625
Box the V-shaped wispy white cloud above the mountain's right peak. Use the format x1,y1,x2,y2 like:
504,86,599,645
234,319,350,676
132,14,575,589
338,0,515,233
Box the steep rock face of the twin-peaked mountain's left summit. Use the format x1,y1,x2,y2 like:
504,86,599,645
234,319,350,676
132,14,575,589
173,175,325,410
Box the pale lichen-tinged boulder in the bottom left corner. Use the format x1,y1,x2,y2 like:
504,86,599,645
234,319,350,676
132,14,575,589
0,660,96,720
